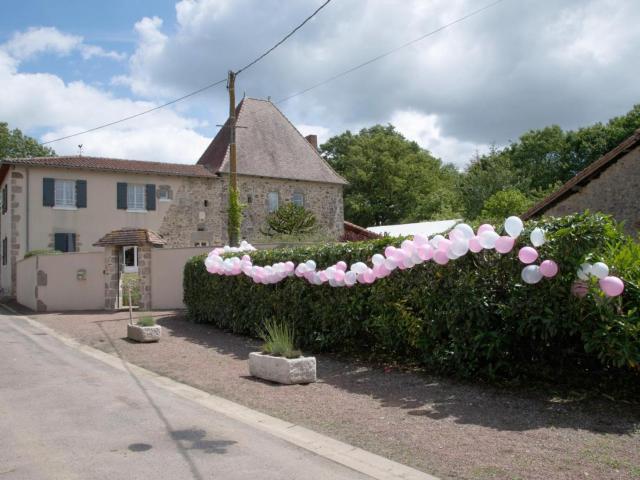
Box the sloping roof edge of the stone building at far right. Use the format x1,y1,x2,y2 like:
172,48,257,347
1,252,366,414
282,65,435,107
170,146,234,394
522,129,640,220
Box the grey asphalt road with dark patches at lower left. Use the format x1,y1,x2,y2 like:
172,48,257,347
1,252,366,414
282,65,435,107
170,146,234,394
0,314,369,480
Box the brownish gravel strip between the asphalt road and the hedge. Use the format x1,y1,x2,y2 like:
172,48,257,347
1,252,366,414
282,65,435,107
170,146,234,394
26,312,640,479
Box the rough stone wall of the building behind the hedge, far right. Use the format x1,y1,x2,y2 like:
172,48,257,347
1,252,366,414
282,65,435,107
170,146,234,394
544,147,640,236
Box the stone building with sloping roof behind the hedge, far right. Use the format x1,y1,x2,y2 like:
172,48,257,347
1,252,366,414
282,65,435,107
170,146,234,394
523,125,640,236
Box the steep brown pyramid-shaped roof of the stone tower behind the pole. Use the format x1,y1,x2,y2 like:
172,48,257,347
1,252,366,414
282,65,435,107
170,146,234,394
198,98,347,185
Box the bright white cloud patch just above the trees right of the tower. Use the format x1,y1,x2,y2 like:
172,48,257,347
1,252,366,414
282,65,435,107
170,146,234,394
390,110,489,168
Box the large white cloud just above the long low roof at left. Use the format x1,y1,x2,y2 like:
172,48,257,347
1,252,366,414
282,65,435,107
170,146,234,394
0,41,210,163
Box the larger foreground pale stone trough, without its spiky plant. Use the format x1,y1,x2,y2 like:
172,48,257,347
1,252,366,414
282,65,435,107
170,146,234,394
249,352,316,385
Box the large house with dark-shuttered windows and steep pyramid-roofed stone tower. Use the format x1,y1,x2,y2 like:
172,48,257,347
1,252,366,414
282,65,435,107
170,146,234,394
0,98,346,295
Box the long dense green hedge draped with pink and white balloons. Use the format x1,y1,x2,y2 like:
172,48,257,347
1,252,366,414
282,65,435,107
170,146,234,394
184,214,640,378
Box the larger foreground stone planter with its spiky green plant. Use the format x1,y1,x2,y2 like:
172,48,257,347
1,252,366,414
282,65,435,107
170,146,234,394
249,320,316,385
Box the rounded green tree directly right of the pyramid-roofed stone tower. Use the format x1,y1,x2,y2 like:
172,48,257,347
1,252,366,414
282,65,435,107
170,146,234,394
320,125,460,226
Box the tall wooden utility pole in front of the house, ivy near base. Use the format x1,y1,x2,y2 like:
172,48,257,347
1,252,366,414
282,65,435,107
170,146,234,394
227,70,242,247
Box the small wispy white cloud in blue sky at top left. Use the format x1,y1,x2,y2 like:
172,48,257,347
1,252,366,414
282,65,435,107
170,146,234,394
0,27,126,61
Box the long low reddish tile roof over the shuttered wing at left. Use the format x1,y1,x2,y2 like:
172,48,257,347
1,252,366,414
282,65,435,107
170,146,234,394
2,156,216,177
